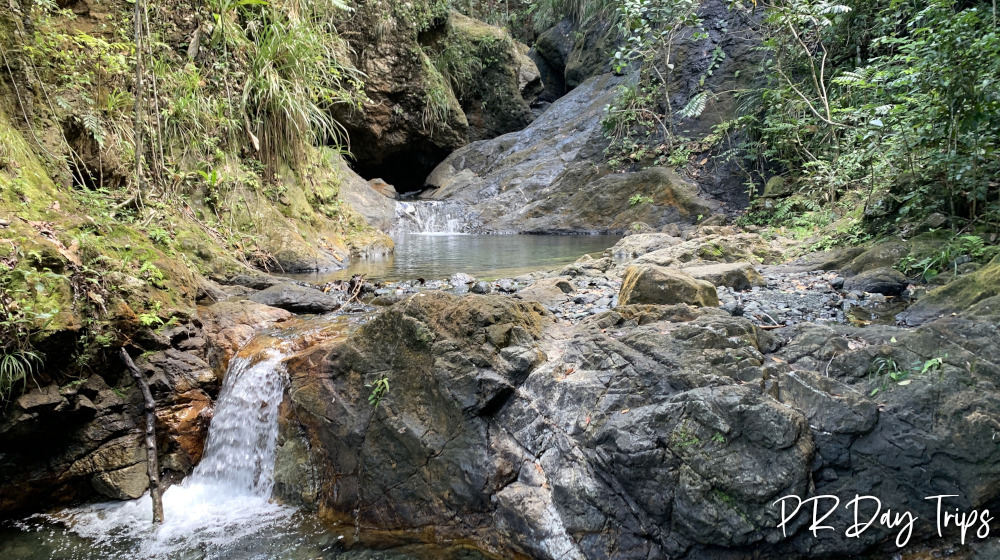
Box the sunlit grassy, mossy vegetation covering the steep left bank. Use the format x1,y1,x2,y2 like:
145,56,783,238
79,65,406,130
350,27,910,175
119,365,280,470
0,0,382,402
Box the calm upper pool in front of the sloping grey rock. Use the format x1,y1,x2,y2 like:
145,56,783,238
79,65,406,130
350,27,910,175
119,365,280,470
296,234,621,283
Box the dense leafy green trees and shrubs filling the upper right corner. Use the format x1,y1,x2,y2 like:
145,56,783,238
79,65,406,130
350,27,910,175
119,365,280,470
740,0,1000,229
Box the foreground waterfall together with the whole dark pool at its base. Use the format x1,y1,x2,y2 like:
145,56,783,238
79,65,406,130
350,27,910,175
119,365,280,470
0,335,492,560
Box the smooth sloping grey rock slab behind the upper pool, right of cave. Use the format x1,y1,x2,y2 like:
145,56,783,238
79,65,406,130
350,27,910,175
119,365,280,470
418,76,718,233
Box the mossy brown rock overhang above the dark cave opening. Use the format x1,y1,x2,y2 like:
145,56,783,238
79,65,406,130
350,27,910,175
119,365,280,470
335,0,540,192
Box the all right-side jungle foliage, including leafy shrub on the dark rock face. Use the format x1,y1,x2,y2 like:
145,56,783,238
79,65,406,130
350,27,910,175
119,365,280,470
584,0,1000,234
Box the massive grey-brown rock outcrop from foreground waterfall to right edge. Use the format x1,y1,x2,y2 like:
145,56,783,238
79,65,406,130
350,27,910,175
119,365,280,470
276,293,1000,560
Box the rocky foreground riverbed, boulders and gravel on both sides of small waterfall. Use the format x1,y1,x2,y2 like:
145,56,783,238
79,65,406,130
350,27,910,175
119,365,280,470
4,221,1000,559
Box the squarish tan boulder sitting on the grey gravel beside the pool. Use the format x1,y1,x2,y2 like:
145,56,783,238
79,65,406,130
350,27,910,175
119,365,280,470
618,265,719,307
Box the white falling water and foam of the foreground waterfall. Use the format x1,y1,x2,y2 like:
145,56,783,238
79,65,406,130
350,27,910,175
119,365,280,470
40,349,296,560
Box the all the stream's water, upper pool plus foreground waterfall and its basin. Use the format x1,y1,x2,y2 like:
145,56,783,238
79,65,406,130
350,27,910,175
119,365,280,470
0,225,619,560
